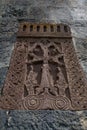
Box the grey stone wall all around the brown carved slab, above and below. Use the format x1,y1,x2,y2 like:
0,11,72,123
0,0,87,130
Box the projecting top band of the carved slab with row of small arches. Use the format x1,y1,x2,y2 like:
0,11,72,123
18,22,71,37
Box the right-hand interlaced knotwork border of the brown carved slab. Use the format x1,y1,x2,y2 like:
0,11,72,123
62,40,87,110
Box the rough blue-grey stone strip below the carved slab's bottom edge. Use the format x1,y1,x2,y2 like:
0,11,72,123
0,110,87,130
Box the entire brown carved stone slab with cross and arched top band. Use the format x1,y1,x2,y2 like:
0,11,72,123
0,22,87,110
